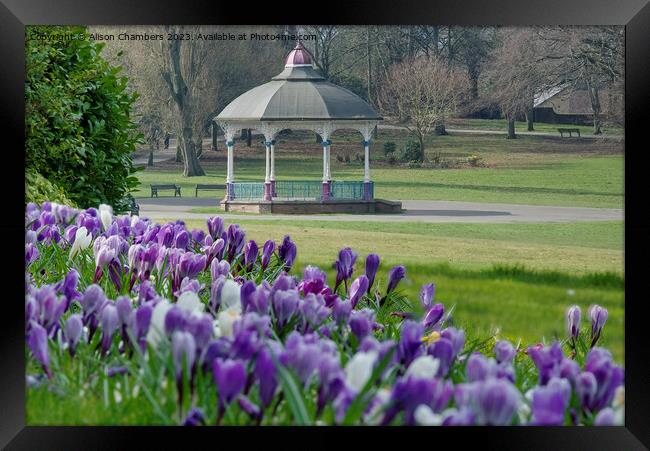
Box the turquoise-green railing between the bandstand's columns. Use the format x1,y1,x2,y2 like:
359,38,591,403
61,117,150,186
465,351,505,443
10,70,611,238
232,180,374,200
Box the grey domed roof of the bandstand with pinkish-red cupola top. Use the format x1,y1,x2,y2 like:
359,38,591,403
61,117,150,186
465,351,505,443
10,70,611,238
215,42,381,122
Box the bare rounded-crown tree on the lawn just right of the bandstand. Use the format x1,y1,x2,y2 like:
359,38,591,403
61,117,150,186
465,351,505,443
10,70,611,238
378,56,468,151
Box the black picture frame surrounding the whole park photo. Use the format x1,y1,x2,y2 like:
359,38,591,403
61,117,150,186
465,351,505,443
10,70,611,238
0,0,650,450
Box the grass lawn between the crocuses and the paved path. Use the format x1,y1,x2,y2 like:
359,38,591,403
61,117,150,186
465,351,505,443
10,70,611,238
159,217,624,362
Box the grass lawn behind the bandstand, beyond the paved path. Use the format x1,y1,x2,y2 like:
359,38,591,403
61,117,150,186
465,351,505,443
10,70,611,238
135,130,624,208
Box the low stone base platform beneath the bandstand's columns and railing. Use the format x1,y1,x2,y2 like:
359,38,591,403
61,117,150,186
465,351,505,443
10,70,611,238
220,199,402,215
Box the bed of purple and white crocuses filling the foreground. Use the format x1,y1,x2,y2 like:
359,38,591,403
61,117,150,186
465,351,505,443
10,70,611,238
25,202,624,425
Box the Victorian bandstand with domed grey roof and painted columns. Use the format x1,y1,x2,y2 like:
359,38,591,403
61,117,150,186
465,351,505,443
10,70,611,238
214,43,401,213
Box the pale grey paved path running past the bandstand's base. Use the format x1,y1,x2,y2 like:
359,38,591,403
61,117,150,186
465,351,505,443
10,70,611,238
137,197,623,223
